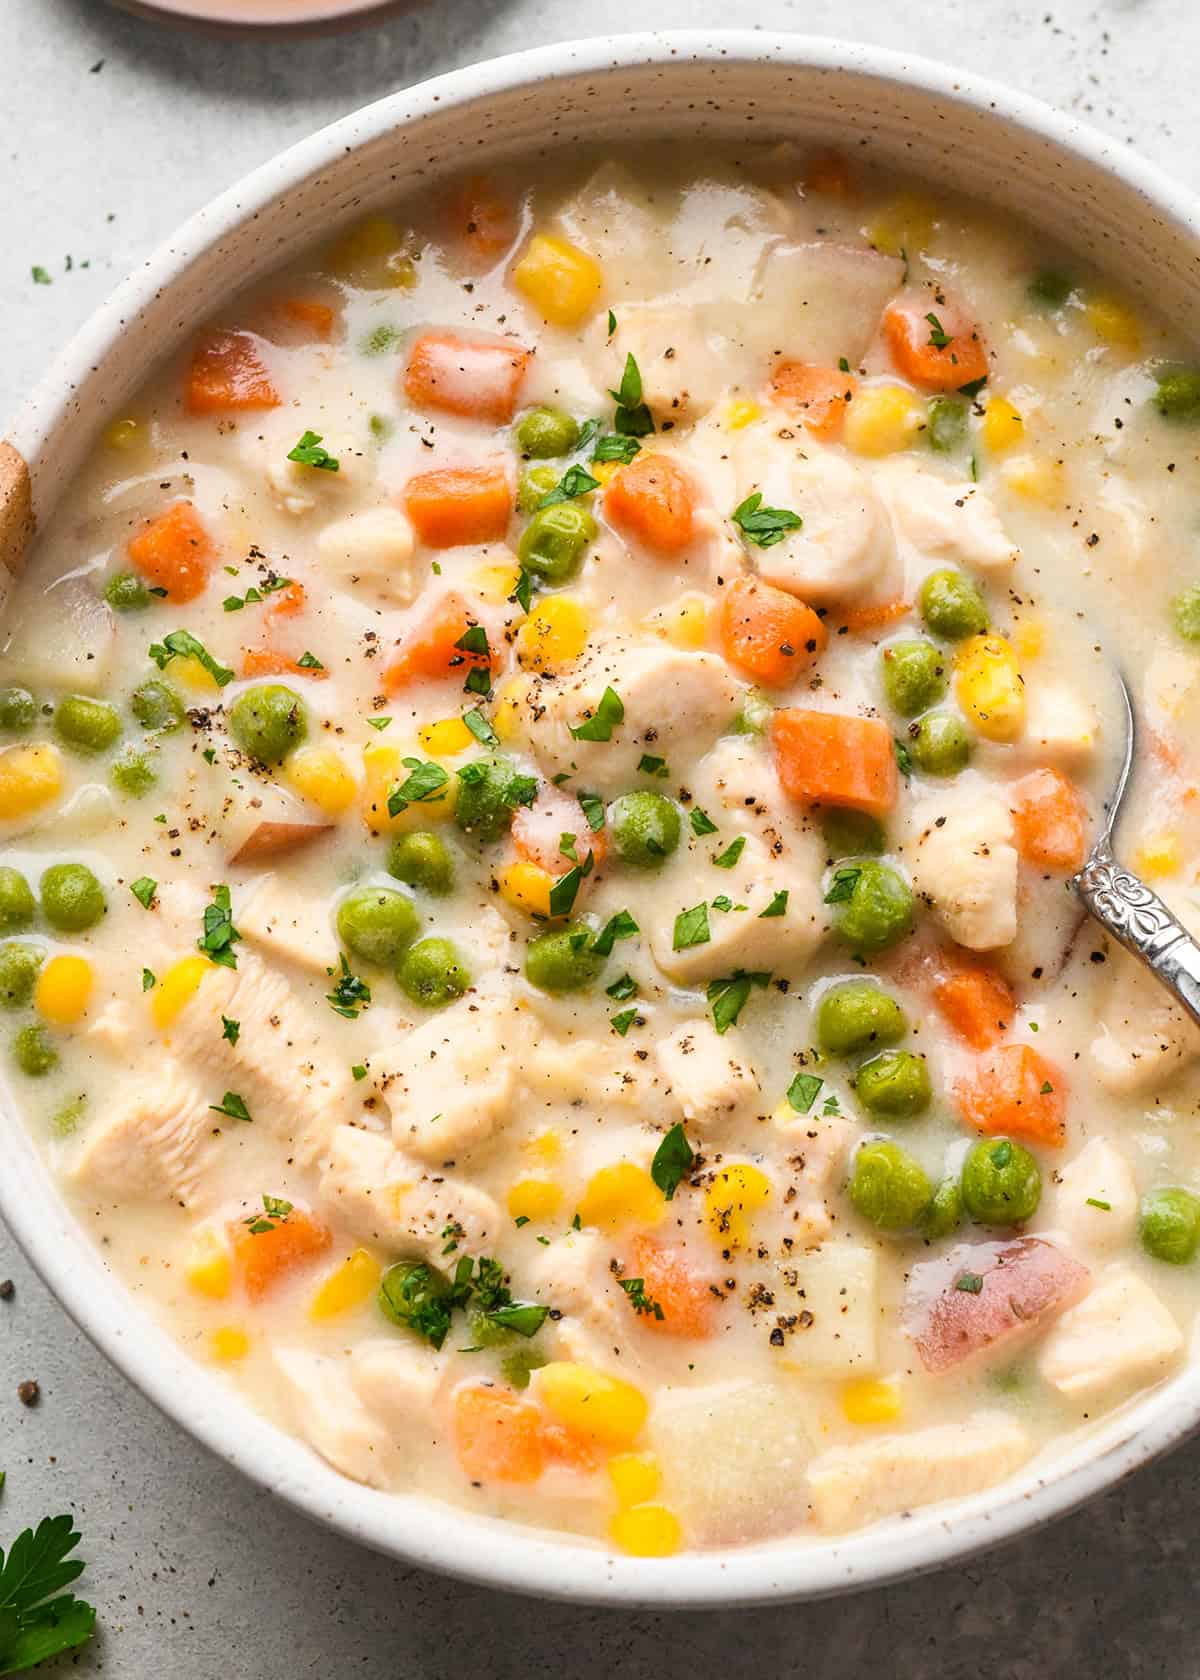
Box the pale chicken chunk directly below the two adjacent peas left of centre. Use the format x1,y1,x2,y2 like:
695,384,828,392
366,995,529,1166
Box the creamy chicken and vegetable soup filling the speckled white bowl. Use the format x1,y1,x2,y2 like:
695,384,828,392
14,148,1200,1556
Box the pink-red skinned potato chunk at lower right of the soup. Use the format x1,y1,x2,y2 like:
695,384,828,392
904,1236,1091,1373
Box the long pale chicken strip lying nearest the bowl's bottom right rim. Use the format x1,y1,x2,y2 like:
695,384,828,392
808,1413,1034,1534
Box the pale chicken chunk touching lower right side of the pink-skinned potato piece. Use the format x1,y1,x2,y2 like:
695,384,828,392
1037,1267,1183,1399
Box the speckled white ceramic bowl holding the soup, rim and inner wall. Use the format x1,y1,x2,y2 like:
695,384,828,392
0,32,1200,1606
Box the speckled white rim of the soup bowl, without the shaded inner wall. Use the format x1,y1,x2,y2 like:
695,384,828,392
0,30,1200,1608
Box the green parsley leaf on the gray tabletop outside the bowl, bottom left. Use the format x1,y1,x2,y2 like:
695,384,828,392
0,1512,96,1675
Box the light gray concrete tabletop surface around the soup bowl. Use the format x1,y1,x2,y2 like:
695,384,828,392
0,0,1200,1680
